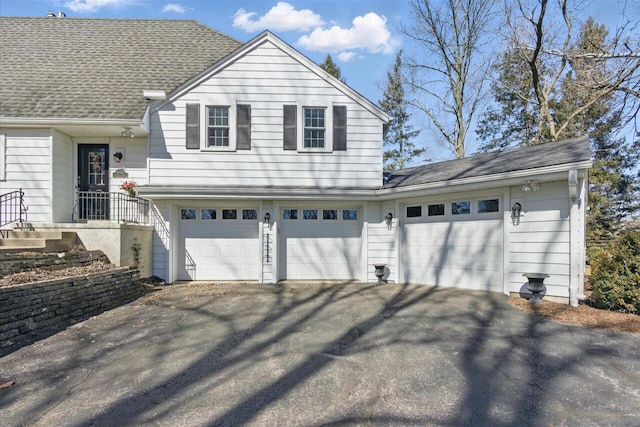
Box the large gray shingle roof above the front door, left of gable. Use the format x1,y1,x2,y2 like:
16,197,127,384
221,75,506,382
0,17,242,119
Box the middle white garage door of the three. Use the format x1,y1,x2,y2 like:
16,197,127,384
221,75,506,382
278,208,362,280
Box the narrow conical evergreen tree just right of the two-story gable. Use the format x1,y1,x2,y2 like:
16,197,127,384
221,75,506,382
380,51,425,170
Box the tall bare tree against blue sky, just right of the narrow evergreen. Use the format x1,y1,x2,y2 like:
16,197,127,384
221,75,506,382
401,0,495,158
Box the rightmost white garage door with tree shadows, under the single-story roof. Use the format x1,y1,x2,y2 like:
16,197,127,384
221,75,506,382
401,198,504,292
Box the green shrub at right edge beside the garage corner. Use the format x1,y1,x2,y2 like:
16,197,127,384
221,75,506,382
590,230,640,314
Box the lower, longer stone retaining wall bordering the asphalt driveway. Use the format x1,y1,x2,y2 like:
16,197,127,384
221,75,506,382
0,267,144,349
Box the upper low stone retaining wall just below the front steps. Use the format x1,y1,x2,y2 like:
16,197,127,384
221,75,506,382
0,251,109,278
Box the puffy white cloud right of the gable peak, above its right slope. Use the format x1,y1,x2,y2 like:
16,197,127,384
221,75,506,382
297,12,397,53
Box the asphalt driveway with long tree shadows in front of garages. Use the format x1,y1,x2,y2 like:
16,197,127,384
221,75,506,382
0,283,640,426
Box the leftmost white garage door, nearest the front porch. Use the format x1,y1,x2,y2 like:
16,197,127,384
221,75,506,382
178,208,260,280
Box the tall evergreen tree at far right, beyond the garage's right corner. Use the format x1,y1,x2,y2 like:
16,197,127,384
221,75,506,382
556,18,638,242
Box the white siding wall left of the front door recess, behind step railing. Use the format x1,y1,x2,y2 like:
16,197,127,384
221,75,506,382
0,129,52,222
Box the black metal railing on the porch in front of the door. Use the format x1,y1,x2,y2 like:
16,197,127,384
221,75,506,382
73,191,151,224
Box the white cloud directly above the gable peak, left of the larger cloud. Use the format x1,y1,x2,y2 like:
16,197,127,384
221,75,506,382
233,2,324,33
